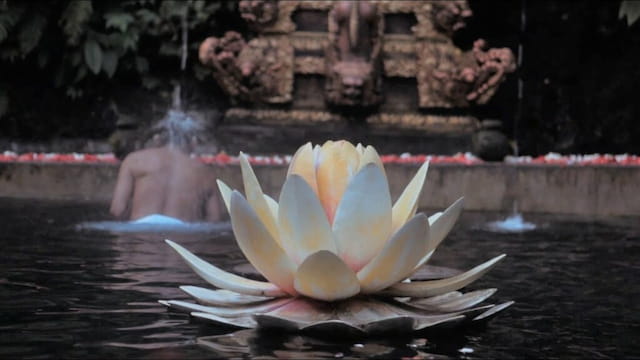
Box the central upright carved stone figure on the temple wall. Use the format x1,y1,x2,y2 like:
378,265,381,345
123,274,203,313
325,1,384,107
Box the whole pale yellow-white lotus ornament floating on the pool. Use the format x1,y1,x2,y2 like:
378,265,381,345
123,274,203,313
161,141,511,334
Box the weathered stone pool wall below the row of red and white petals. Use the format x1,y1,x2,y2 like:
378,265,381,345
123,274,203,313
0,163,640,217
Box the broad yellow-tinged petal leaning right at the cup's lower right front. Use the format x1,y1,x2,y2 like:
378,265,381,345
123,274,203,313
358,214,429,293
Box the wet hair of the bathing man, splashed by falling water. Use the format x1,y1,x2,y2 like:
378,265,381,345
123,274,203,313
149,110,206,150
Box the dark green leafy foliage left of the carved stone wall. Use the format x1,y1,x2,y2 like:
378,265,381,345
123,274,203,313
0,0,235,118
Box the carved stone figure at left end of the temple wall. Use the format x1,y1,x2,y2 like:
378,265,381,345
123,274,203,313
198,31,293,103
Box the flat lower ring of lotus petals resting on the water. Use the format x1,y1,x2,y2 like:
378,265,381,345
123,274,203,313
160,286,513,337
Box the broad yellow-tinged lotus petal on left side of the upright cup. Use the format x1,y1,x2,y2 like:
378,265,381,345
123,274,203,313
231,191,296,295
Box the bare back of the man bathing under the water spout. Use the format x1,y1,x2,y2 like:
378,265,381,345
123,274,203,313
111,146,220,222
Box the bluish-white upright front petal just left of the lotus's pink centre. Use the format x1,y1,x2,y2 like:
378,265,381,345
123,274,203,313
278,174,337,264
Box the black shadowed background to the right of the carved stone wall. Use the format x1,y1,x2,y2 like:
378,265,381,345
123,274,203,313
465,0,640,155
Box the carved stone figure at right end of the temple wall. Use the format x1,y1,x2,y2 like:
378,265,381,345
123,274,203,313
432,39,516,106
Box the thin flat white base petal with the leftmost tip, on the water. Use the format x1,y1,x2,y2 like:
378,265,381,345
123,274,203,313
164,298,293,318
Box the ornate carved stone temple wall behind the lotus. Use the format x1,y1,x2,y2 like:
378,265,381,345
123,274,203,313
199,0,515,153
